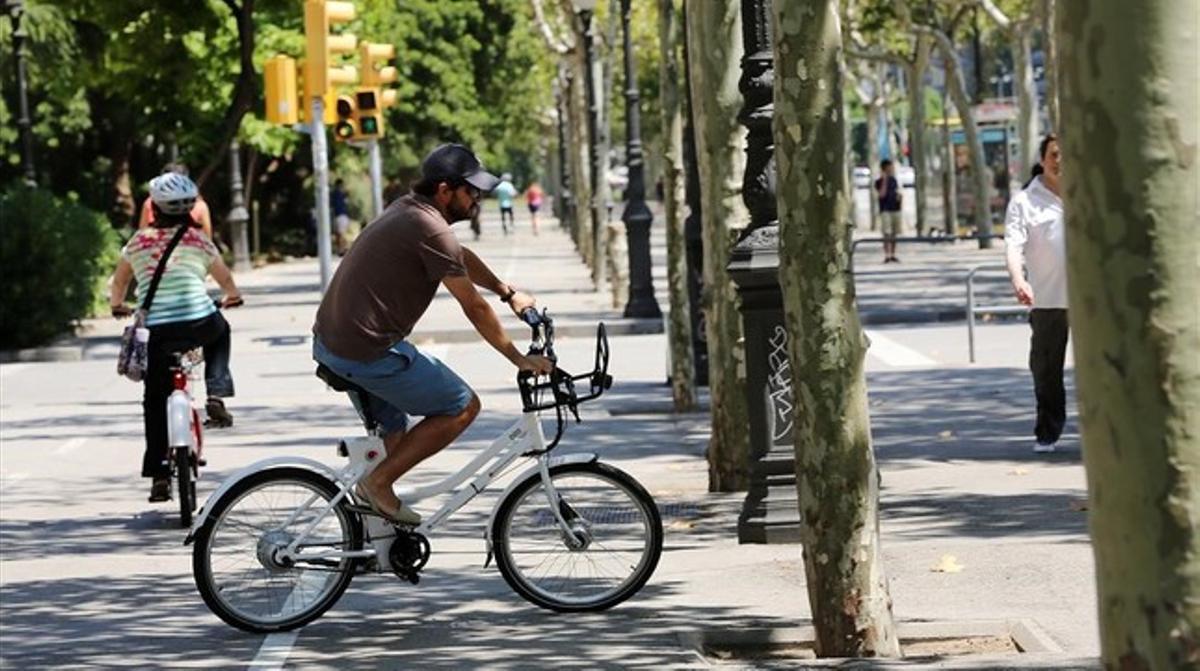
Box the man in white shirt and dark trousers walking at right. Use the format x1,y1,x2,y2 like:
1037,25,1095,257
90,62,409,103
1004,134,1068,453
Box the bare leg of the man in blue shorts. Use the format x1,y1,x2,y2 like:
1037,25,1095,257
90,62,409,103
362,395,480,507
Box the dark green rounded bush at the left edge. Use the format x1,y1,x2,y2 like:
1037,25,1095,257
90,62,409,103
0,184,119,349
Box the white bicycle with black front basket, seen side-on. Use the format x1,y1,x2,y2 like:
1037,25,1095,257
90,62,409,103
185,310,662,633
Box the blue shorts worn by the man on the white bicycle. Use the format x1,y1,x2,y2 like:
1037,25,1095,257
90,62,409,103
312,337,474,433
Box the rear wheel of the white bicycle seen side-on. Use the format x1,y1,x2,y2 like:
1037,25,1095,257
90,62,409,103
192,467,362,634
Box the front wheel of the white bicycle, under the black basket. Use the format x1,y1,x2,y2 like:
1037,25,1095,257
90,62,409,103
492,462,662,612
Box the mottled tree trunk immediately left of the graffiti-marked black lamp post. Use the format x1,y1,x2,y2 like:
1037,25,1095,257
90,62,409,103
686,0,750,491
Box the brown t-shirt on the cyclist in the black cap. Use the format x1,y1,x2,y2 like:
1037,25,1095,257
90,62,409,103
312,193,467,361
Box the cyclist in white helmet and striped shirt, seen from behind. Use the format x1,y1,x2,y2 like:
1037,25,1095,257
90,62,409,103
109,172,241,502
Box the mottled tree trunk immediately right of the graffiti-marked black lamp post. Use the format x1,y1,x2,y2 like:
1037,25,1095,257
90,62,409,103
774,0,900,657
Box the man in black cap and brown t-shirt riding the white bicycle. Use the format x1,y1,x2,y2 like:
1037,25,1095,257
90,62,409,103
312,144,553,525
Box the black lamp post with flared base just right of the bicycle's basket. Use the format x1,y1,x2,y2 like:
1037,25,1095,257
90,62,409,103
620,0,662,319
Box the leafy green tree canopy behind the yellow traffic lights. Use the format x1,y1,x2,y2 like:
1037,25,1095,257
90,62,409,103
0,0,553,246
